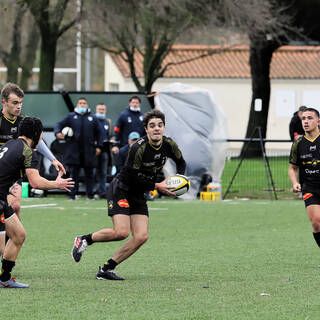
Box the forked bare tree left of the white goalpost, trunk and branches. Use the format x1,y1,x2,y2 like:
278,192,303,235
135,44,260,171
18,0,83,90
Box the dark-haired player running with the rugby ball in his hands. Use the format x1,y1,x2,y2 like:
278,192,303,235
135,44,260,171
71,110,186,280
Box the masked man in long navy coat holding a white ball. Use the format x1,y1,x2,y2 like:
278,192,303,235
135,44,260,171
54,98,102,200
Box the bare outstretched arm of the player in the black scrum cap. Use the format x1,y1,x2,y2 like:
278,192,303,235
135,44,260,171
26,168,74,191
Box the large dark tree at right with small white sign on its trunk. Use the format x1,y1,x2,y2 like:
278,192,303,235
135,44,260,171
241,0,312,157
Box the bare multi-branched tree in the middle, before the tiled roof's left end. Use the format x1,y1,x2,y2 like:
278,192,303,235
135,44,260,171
87,0,212,92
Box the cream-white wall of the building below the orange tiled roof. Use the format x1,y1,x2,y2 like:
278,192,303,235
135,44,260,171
105,55,320,150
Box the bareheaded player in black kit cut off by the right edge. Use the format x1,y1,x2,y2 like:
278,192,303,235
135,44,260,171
288,108,320,254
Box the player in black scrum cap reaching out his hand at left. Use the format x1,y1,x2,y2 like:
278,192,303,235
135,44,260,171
0,117,74,288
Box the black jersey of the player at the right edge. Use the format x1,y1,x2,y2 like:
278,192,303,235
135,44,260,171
289,134,320,191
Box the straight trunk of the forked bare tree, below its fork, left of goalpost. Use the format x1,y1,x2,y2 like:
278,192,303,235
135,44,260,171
39,34,57,91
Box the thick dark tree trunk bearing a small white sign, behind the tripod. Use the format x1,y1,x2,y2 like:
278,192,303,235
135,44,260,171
241,41,279,157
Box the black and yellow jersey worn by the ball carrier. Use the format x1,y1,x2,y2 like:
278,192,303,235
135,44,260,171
117,136,186,193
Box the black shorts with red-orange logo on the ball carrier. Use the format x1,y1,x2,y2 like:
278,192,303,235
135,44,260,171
107,178,149,217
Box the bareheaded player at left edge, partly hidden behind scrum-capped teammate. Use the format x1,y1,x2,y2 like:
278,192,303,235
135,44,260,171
0,82,66,255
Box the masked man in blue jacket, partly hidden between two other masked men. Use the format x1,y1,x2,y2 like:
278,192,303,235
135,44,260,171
95,102,111,199
